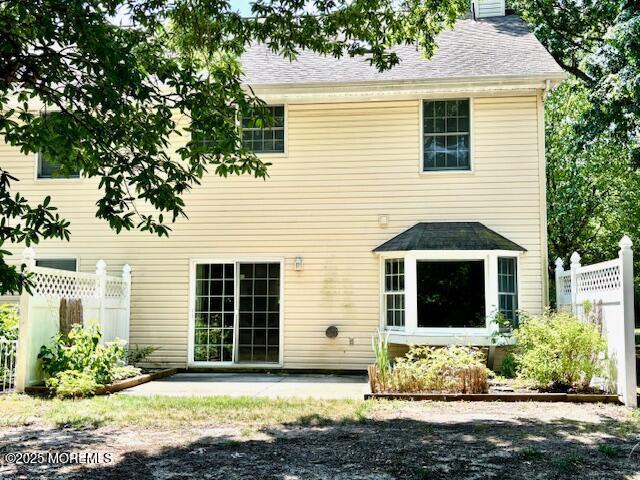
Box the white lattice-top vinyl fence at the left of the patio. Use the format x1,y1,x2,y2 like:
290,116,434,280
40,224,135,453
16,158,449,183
15,248,131,392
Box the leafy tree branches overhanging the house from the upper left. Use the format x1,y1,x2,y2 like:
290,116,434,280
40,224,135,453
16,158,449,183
0,0,468,294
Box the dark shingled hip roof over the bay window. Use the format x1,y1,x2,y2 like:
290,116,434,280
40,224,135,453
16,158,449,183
373,222,526,252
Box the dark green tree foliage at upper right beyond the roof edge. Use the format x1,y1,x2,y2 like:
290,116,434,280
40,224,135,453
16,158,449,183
510,0,640,167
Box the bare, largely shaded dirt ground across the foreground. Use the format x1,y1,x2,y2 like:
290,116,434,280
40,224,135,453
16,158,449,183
0,402,640,480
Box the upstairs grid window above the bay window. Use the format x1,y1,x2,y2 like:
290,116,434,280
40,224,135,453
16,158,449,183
422,99,471,172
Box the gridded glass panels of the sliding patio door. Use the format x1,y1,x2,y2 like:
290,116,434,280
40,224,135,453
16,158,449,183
193,262,281,364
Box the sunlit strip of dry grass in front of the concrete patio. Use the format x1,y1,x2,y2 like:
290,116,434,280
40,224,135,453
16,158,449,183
0,395,373,428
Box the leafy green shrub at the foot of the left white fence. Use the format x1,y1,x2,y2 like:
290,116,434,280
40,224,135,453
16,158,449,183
38,325,140,397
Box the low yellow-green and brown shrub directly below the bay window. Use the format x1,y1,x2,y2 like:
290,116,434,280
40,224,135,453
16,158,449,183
389,345,489,393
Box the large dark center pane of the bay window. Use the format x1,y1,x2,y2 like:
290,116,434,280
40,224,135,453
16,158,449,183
416,260,486,328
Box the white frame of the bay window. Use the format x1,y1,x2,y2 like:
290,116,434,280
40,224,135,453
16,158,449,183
380,250,522,345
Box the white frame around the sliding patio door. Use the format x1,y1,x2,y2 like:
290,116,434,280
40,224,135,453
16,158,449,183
187,257,285,369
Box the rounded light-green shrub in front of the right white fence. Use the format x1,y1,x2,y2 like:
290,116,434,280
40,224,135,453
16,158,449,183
514,312,607,391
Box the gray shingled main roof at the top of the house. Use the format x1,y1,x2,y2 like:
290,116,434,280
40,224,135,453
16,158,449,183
242,15,563,86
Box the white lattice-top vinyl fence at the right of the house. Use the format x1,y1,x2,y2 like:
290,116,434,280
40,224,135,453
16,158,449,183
556,235,638,407
